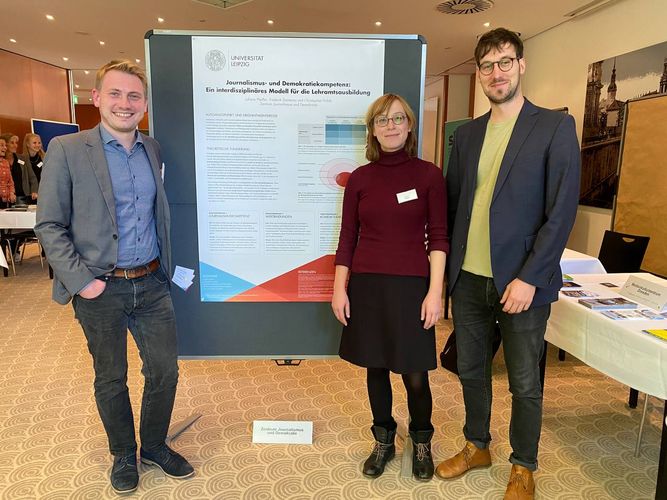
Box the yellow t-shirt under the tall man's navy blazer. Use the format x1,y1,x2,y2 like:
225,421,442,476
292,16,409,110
463,115,518,278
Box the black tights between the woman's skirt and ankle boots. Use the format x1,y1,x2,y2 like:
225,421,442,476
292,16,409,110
366,368,433,431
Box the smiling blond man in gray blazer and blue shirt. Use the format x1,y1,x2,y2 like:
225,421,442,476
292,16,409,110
35,61,194,493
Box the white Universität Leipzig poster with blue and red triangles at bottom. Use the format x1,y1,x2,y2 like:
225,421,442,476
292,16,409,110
192,36,384,302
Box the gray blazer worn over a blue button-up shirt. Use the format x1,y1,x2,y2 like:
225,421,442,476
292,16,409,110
35,125,171,304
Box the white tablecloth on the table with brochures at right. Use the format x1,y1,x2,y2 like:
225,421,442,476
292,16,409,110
545,273,667,399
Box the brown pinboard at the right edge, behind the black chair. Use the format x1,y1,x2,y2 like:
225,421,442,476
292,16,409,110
612,94,667,276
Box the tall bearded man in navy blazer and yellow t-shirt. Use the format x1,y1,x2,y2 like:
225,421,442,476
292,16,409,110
436,28,580,499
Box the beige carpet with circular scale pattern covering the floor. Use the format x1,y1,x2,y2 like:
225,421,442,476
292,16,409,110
0,250,662,500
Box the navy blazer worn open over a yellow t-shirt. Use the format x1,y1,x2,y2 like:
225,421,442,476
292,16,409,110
447,99,581,307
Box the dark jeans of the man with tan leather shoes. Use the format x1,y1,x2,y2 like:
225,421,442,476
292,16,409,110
452,271,551,470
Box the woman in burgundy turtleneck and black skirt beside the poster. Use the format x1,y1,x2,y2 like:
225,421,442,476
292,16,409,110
331,94,449,481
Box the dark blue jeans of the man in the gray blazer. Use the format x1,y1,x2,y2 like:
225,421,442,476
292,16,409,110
73,269,178,456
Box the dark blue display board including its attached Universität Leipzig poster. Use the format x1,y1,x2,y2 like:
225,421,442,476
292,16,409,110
146,31,426,358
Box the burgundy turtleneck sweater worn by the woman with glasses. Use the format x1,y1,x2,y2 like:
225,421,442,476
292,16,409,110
335,150,449,276
